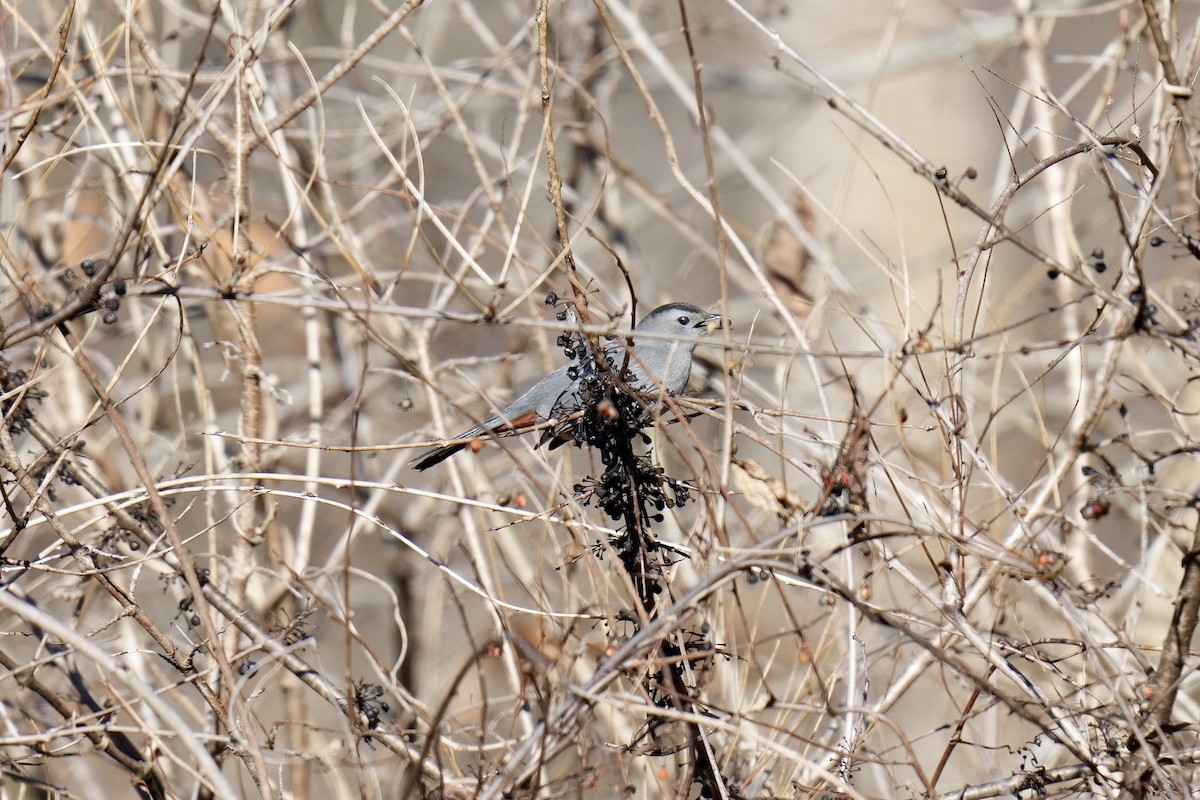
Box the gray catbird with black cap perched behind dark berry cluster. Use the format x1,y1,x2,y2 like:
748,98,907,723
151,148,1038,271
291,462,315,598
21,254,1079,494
413,302,721,469
